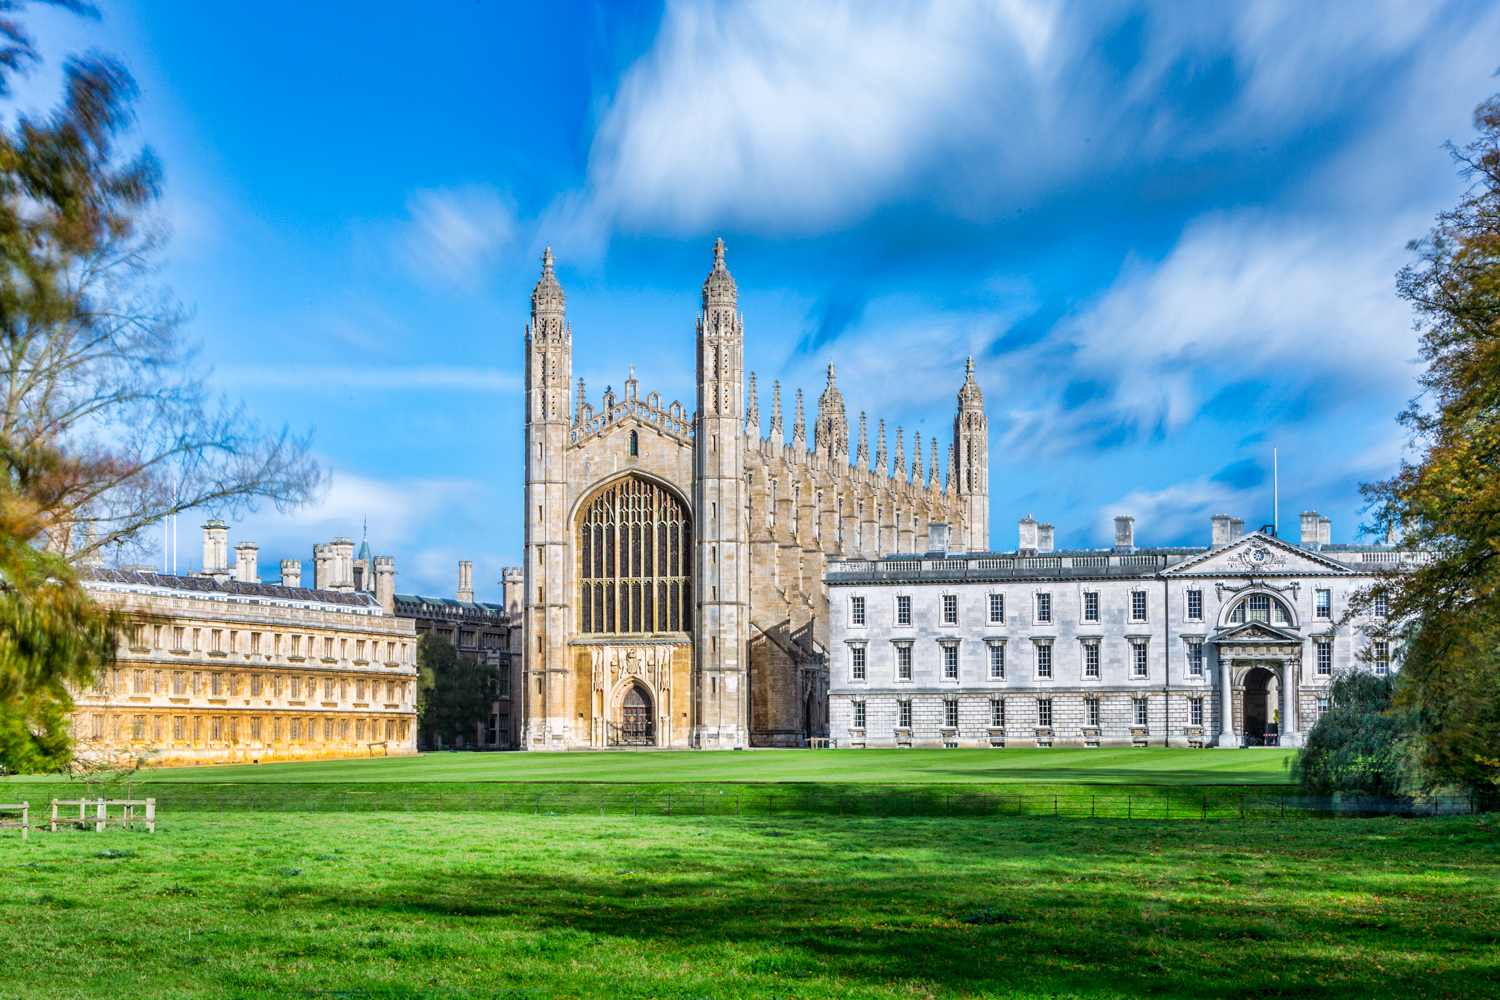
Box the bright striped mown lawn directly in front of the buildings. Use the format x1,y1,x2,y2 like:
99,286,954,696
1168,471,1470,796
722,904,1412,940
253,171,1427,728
0,747,1295,795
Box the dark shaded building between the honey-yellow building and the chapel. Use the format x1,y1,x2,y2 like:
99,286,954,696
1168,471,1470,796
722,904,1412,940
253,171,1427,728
395,559,521,750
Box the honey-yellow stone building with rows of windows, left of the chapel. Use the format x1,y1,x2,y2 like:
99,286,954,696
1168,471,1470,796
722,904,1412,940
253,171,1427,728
72,522,417,765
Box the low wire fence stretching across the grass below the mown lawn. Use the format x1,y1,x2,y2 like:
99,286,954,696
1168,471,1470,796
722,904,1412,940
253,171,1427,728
93,786,1500,820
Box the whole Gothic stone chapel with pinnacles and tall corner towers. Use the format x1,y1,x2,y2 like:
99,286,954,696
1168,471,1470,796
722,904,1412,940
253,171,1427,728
522,240,990,750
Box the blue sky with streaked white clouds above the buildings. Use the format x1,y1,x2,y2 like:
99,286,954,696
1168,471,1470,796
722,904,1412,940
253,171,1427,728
18,0,1500,598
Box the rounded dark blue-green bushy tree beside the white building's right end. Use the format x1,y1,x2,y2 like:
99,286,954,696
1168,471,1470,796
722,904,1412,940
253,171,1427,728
1293,670,1425,795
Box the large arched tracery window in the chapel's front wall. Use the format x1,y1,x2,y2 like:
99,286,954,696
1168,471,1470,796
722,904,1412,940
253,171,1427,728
578,477,693,633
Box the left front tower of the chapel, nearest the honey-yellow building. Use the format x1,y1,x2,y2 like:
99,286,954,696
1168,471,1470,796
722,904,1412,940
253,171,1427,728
522,247,573,747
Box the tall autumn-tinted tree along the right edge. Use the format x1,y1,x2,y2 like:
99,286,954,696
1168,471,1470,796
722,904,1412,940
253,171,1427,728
1355,97,1500,789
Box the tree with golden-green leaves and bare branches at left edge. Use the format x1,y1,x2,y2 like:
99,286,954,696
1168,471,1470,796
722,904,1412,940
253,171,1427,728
0,0,324,769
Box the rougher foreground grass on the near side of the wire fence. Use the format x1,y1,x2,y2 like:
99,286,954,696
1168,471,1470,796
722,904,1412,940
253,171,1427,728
0,809,1500,1000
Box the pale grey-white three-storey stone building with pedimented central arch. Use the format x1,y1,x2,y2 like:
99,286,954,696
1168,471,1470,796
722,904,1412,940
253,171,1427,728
828,513,1404,747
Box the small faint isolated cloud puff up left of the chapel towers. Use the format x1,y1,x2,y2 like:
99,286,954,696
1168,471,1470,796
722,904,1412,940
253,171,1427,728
396,186,516,291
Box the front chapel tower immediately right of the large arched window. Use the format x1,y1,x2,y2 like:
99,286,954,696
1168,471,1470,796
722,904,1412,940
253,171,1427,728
693,240,750,747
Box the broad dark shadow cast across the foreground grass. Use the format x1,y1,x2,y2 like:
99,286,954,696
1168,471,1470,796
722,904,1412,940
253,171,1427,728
270,820,1500,1000
